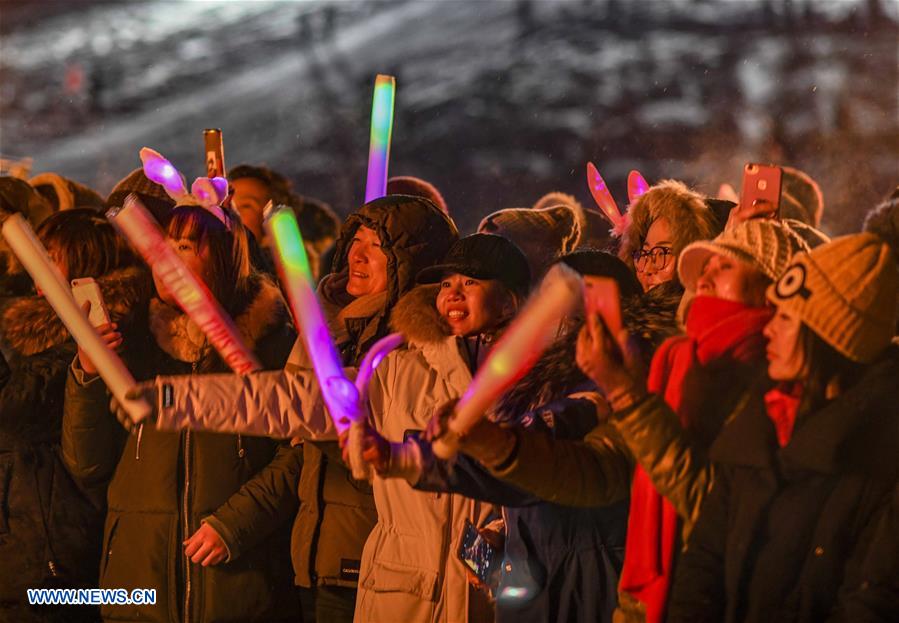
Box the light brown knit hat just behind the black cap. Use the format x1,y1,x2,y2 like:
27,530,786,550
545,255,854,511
478,204,583,283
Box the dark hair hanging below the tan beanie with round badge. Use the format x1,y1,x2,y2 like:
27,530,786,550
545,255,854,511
799,323,867,415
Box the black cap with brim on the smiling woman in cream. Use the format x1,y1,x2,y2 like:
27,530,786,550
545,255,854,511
417,234,531,295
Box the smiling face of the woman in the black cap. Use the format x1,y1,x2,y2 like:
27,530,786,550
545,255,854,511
437,274,516,336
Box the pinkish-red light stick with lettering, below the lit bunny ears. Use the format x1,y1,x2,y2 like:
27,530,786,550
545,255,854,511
107,194,262,374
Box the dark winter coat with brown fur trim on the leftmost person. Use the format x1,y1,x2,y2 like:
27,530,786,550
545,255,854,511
0,268,152,621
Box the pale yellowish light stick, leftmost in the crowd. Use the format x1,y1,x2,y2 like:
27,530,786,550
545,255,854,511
3,214,152,423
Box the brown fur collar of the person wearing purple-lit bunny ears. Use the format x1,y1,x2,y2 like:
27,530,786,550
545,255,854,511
149,275,287,363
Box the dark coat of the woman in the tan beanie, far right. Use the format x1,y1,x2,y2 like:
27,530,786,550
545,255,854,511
668,349,899,623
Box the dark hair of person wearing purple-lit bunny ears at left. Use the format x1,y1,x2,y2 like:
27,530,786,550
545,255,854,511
166,206,252,313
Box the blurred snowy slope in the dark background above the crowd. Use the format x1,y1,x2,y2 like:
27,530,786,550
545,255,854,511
0,0,899,233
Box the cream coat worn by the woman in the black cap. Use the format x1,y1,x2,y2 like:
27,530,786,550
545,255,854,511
354,287,499,623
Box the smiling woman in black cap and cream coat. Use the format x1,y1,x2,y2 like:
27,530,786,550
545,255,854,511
344,234,530,623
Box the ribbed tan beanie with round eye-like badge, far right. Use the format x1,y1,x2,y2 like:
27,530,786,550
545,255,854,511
767,233,899,363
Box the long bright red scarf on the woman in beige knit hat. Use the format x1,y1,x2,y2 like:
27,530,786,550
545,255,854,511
620,296,772,623
